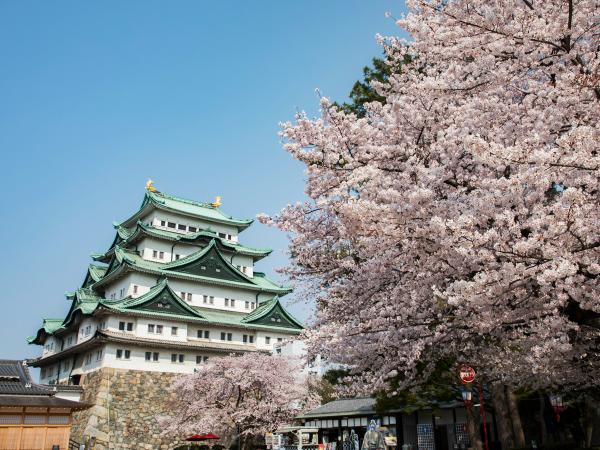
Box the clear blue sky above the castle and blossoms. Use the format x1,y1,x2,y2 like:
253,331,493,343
0,0,403,358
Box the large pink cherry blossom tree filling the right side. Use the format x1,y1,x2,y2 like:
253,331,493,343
259,0,600,418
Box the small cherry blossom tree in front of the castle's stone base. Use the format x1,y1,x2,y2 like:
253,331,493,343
159,353,316,448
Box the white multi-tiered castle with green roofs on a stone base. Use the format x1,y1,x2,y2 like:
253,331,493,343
29,181,302,449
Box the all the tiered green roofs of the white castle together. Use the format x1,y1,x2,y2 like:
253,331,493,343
27,191,303,350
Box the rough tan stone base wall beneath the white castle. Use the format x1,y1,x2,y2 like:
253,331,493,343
71,368,188,450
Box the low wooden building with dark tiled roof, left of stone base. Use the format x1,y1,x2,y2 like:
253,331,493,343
0,359,87,450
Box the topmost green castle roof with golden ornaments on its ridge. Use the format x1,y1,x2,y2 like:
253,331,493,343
118,191,253,231
